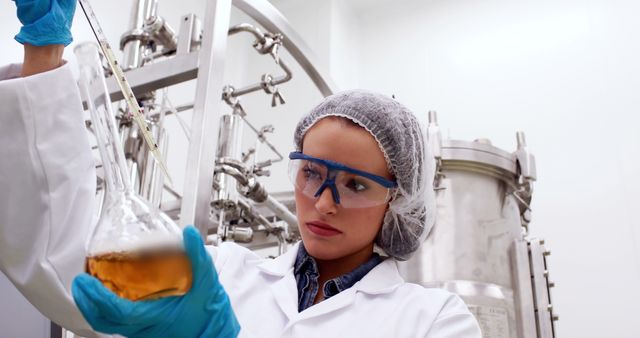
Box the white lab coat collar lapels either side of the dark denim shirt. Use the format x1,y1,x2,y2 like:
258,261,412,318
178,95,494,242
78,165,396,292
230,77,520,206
258,242,404,294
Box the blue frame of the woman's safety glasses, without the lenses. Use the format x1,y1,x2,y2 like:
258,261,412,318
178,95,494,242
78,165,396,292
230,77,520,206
289,151,398,204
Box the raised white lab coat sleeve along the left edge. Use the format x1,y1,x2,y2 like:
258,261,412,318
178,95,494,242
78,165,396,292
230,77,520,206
0,65,101,337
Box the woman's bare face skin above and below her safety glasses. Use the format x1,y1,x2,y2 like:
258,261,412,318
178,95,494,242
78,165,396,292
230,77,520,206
295,117,392,260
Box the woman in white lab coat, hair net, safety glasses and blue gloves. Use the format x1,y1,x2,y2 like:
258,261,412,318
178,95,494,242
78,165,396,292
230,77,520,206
0,0,480,338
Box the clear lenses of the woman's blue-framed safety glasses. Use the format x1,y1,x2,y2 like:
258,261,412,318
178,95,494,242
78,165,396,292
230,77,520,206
289,160,391,208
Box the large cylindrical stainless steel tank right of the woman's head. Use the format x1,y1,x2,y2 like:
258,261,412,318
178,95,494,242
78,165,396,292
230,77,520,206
399,112,557,338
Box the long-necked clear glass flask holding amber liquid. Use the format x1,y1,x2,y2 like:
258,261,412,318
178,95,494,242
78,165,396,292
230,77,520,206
74,43,191,301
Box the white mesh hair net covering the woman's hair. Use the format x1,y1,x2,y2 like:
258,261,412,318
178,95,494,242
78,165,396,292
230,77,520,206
294,90,435,260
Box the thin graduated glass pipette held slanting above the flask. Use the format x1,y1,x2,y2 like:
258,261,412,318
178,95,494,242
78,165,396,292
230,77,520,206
78,0,172,185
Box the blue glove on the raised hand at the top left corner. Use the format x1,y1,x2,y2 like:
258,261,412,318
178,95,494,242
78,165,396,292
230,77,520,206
13,0,77,46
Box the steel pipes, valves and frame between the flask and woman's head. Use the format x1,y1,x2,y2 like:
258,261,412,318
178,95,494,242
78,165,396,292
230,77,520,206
79,0,334,254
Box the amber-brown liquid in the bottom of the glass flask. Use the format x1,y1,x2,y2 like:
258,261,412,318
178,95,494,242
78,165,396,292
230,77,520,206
87,250,191,301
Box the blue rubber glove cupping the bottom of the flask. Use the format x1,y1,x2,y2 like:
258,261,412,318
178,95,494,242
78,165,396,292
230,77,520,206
71,226,240,338
